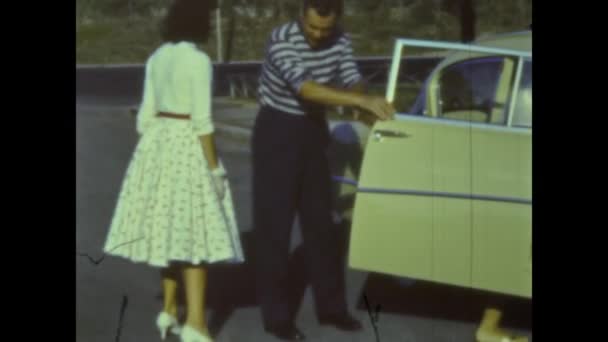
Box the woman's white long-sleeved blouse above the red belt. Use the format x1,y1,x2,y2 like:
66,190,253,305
137,42,214,136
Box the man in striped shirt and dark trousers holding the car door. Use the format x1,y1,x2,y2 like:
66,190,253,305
252,0,394,341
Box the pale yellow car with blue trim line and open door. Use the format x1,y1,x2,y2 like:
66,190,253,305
348,31,532,298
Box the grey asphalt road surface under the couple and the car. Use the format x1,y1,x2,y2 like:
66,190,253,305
76,97,532,342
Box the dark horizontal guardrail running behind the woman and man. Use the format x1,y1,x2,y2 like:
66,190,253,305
76,57,441,99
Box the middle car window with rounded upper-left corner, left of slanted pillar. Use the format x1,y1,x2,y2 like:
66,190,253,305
439,57,506,124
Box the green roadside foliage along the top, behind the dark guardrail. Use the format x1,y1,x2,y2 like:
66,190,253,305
76,0,532,63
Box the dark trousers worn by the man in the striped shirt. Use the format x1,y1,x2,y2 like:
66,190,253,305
252,107,346,327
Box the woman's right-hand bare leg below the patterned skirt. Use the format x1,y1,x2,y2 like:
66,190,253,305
183,266,209,335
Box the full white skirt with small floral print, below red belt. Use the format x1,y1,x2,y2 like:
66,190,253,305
103,118,244,267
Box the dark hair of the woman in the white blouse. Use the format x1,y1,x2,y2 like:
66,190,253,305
162,0,215,43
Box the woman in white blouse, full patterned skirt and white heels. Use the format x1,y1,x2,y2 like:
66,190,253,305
104,0,244,342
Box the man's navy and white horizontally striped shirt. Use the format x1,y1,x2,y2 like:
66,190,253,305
258,21,362,115
